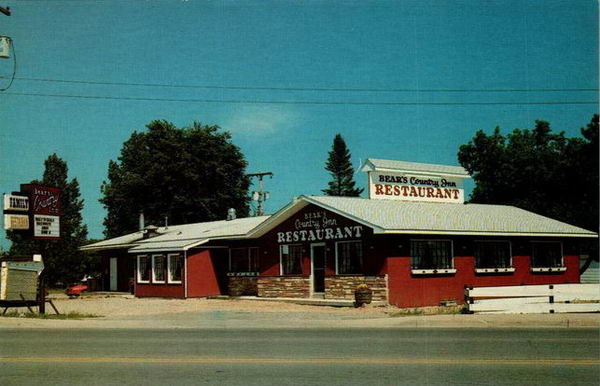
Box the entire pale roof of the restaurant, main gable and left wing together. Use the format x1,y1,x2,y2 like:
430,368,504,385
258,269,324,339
81,196,598,253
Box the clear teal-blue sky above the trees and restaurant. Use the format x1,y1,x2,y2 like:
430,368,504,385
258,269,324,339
0,0,598,248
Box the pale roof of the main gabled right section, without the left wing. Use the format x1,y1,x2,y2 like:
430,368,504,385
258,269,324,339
249,196,598,238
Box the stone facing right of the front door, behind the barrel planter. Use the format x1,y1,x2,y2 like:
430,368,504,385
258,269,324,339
325,275,388,301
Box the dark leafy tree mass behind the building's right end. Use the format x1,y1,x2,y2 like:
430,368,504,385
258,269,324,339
458,114,599,272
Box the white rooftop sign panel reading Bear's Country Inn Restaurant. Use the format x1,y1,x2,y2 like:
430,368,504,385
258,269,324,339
369,172,464,203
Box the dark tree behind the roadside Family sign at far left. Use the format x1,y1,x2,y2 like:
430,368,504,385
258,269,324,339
7,154,90,285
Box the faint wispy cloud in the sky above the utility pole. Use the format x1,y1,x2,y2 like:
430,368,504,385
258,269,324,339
223,106,298,136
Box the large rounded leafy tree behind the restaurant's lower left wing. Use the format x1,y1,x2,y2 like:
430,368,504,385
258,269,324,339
100,121,249,237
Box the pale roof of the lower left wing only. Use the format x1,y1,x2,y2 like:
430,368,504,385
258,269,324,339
81,216,269,253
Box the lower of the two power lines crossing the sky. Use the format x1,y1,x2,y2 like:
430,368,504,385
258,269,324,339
3,92,598,106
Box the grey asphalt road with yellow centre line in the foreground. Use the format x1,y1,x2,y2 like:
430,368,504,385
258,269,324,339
0,328,600,386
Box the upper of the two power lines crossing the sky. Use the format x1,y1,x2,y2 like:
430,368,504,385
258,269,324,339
5,77,600,93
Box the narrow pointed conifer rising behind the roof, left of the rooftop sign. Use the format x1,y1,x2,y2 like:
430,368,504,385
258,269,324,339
323,133,364,197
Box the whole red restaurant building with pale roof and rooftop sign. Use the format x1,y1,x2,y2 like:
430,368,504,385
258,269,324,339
82,159,598,307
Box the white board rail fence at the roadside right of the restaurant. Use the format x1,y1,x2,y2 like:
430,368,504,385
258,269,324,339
465,284,600,314
